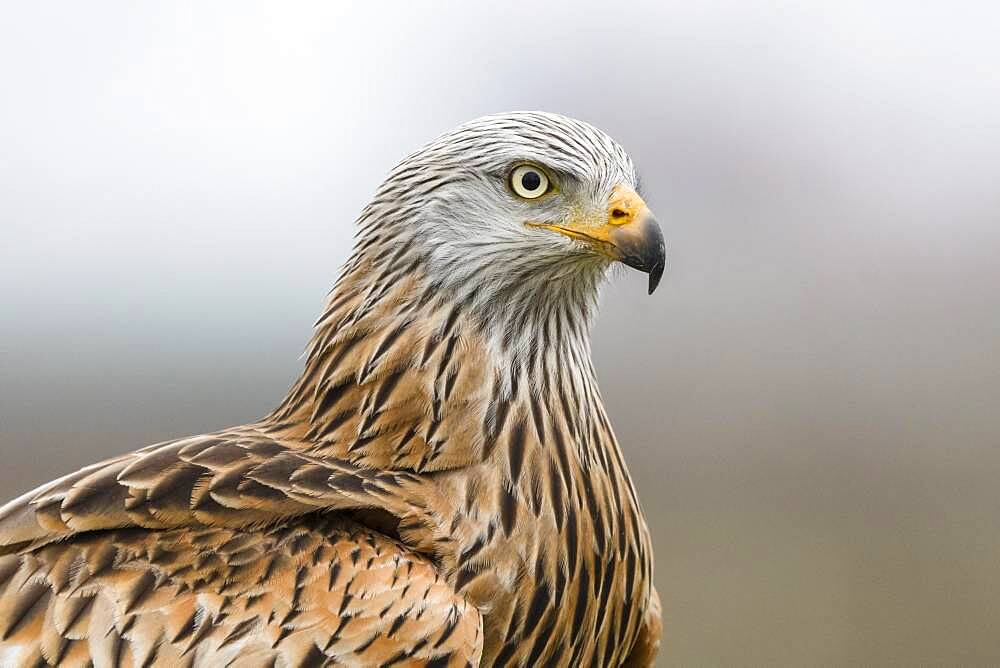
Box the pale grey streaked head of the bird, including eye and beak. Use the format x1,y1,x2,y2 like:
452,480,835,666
348,112,665,336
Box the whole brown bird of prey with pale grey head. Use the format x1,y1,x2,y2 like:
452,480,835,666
0,112,665,667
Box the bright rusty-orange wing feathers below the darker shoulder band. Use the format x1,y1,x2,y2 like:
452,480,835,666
0,516,482,667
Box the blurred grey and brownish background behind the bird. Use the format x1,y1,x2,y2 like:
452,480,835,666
0,2,1000,666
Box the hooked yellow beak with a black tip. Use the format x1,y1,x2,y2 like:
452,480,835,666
529,185,667,294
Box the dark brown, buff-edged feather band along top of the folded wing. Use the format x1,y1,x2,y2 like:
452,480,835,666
0,426,442,554
